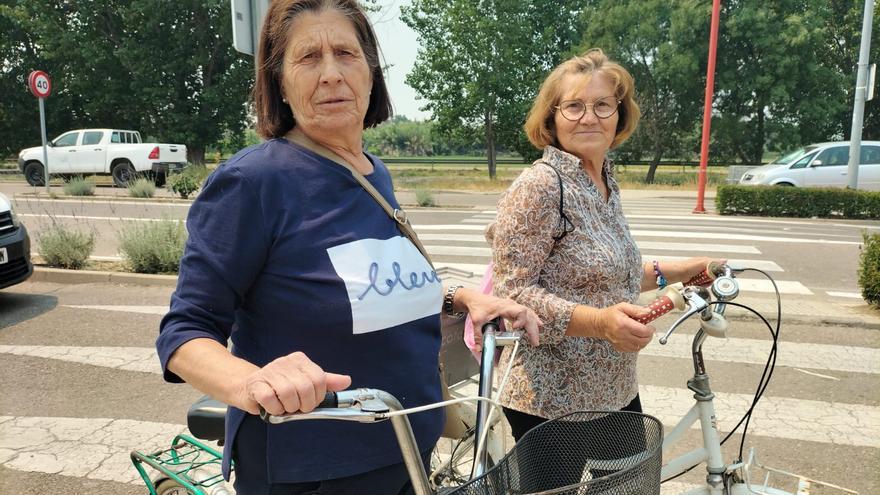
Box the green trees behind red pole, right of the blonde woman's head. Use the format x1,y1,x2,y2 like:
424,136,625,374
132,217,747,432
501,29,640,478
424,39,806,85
576,0,880,178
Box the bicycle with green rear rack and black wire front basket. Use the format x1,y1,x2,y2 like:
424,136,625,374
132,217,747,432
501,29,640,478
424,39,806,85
131,322,663,495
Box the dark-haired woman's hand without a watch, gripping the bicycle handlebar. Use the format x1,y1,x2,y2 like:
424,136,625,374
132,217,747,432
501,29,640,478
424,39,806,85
243,352,351,415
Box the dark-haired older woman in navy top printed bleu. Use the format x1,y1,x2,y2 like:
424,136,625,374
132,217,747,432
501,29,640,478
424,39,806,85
156,0,540,495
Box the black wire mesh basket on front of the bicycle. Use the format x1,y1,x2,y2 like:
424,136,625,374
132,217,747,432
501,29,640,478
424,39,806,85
445,411,663,495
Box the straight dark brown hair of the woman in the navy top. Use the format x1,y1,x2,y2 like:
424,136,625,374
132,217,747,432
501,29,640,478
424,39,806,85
253,0,393,139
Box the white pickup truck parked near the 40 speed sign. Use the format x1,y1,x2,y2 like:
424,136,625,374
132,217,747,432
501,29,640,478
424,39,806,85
18,129,186,187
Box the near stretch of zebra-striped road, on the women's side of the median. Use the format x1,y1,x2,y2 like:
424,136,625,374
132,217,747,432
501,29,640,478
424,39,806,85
0,283,880,495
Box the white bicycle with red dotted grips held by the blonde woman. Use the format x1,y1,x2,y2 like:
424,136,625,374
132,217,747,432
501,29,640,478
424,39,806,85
639,263,857,495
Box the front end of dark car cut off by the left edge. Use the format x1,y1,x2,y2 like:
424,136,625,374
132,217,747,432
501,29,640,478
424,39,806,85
0,194,34,289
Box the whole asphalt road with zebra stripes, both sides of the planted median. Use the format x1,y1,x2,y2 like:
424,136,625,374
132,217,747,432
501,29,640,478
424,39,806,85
0,184,880,494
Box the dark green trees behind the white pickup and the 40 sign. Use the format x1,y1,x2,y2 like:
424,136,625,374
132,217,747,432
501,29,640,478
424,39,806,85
0,0,253,162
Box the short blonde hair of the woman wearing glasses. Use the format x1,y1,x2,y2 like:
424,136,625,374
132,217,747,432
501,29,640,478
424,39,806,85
523,48,641,149
